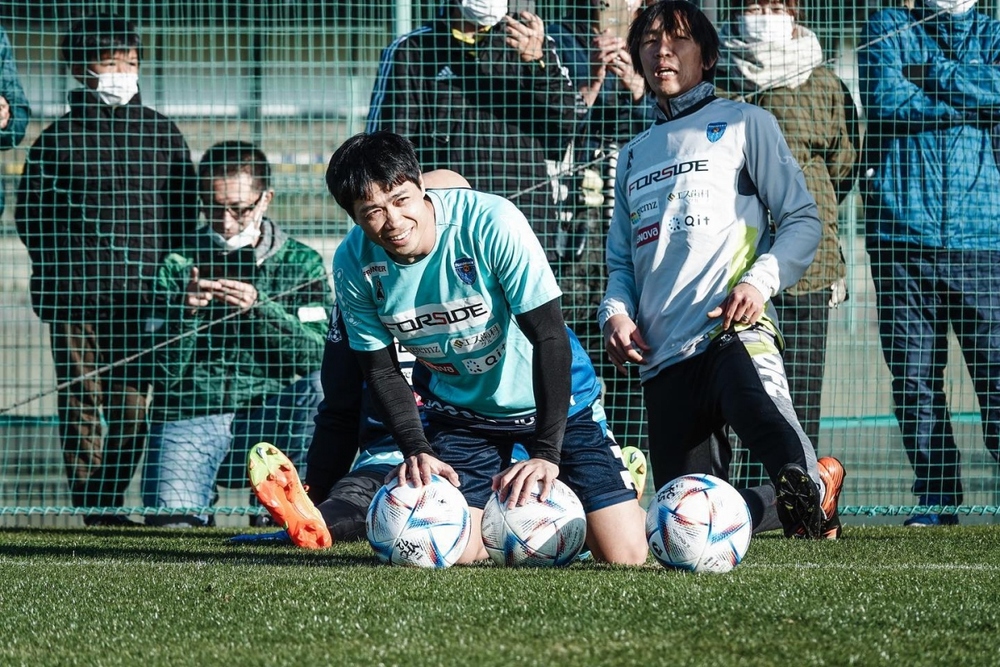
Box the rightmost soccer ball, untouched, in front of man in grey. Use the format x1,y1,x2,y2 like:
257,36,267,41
646,475,752,572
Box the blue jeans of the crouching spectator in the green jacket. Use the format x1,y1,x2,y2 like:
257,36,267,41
142,371,323,526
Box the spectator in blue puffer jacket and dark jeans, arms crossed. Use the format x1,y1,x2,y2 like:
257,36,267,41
858,0,1000,526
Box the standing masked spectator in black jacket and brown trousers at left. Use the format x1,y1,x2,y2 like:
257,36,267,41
16,9,198,525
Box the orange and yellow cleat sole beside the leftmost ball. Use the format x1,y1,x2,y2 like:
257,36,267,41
247,442,333,549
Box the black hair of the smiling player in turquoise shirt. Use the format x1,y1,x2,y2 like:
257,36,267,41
326,130,420,217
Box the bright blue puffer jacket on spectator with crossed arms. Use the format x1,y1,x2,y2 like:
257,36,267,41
858,8,1000,250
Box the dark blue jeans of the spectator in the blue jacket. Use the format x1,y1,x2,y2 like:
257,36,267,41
868,241,1000,504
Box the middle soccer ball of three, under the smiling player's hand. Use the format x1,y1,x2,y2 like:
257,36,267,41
483,480,587,567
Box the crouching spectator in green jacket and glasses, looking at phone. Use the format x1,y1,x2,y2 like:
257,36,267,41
142,141,333,525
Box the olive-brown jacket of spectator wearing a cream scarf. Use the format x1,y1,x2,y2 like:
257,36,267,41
716,58,857,295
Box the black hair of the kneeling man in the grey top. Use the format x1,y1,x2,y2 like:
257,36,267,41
626,0,719,91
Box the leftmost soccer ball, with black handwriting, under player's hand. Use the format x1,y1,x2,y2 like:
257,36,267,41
365,475,472,568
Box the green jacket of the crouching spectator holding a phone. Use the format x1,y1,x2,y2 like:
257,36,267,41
147,219,333,422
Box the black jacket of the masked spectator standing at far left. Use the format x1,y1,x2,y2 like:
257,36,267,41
16,89,198,322
